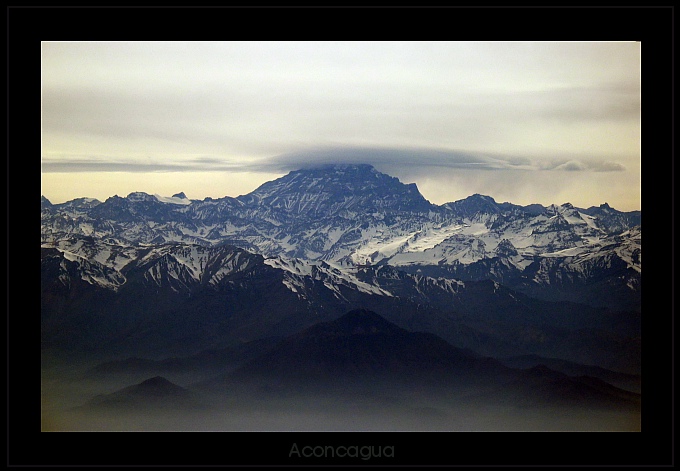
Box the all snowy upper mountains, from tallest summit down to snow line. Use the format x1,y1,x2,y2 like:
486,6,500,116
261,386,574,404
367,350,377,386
41,165,641,310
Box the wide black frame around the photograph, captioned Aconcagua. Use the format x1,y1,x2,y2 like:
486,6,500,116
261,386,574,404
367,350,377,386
11,6,675,467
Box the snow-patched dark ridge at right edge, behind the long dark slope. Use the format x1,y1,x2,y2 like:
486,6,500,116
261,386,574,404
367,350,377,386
399,226,642,311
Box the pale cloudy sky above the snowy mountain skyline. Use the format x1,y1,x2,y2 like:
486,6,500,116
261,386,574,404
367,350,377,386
41,41,641,211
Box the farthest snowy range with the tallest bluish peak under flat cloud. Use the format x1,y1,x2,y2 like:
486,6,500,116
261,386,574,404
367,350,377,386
41,165,636,265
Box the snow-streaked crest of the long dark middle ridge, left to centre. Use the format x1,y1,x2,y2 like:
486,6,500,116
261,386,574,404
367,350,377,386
43,234,484,308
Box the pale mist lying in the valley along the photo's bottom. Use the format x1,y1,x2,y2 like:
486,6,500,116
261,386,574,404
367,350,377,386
41,360,641,432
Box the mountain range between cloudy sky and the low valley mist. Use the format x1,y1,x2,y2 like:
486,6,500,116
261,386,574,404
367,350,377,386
41,165,641,432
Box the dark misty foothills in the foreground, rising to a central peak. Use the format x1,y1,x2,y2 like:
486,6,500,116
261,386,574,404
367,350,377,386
46,309,640,430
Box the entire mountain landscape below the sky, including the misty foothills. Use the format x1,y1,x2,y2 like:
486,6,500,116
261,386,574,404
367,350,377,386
41,165,642,430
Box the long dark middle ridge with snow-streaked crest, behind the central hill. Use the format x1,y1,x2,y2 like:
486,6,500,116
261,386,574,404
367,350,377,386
41,237,640,372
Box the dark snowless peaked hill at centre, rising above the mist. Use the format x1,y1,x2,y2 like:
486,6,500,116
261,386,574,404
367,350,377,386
228,309,484,382
